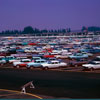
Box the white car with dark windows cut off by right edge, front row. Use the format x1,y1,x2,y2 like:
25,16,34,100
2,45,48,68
82,62,100,70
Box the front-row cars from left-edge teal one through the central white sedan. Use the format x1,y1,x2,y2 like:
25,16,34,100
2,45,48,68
0,56,67,69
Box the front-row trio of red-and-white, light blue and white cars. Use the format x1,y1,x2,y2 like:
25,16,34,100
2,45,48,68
13,59,67,69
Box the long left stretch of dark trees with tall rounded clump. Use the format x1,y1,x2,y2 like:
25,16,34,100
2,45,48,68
0,26,71,35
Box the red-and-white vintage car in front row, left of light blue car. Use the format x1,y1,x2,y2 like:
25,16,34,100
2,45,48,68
13,59,31,68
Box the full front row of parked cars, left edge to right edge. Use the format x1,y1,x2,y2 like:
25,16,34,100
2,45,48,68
0,56,100,70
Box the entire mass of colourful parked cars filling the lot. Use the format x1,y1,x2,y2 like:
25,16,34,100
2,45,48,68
0,38,100,69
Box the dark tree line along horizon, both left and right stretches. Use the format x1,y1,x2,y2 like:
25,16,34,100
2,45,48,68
0,26,100,36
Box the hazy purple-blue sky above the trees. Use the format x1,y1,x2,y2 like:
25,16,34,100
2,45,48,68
0,0,100,31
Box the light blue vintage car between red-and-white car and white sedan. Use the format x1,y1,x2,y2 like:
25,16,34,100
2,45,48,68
26,59,47,68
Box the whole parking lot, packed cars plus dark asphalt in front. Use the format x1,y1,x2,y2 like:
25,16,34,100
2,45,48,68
0,38,100,99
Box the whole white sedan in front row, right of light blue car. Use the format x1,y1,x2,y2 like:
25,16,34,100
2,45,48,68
41,61,67,69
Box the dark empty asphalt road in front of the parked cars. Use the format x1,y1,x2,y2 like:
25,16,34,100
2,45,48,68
0,68,100,98
